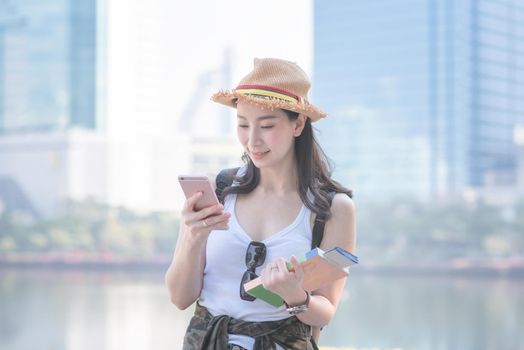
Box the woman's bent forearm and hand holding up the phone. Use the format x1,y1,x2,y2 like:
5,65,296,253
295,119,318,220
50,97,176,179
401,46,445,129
165,193,230,310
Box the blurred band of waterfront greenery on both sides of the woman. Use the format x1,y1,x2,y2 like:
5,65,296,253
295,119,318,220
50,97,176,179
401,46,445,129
0,198,524,261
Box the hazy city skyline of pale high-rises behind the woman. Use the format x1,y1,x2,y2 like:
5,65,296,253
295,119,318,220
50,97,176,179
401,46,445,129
0,0,524,219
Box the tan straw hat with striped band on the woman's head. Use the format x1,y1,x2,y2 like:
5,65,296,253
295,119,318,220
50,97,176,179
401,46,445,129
211,58,326,122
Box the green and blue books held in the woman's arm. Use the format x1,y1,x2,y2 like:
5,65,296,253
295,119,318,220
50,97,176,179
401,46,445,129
244,247,358,307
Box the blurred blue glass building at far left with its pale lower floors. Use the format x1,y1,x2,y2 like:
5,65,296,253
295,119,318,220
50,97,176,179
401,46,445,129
0,0,107,217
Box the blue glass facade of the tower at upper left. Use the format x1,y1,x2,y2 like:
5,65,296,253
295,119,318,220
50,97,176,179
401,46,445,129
0,0,97,133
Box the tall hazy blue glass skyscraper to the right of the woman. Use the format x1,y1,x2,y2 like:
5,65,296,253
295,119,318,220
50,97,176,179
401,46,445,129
314,0,524,200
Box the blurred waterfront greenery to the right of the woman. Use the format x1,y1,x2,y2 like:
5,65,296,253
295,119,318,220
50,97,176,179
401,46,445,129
357,199,524,261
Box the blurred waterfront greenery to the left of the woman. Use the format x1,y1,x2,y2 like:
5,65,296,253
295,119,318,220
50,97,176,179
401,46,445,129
0,200,178,258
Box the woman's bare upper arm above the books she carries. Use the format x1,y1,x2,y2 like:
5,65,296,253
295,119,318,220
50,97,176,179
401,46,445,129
321,193,356,252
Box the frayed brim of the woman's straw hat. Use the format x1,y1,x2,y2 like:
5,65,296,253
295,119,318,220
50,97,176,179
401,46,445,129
211,90,327,122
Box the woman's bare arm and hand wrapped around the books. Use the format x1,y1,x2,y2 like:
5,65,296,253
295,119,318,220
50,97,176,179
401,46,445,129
262,194,356,327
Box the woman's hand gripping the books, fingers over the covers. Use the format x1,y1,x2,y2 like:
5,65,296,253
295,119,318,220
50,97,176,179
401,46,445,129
261,256,305,305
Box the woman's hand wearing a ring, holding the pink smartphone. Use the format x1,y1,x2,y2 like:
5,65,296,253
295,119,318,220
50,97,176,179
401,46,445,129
182,192,231,238
